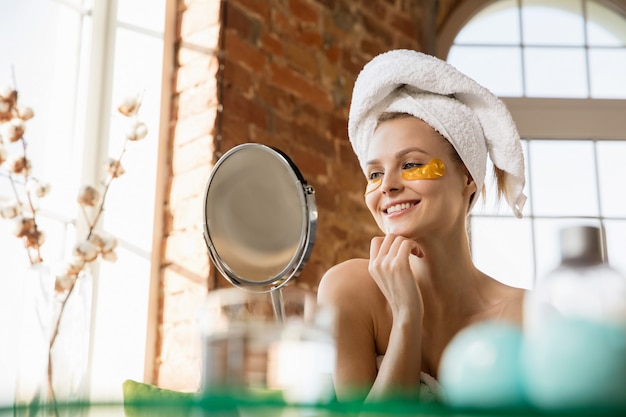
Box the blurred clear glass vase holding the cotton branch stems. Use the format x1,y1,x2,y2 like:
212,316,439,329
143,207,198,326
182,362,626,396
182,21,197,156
15,264,93,416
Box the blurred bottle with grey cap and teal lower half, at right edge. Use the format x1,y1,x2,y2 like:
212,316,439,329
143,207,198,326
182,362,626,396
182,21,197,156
522,226,626,410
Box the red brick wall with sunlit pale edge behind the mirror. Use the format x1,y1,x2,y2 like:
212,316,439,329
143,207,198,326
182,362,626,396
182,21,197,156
152,0,449,390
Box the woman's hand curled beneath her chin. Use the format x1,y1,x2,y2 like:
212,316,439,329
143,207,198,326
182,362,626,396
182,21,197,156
368,234,423,319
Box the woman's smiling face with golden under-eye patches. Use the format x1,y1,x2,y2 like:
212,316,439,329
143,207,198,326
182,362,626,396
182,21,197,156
365,117,476,238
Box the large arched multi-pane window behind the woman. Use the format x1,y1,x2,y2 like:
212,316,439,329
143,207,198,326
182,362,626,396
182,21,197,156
438,0,626,288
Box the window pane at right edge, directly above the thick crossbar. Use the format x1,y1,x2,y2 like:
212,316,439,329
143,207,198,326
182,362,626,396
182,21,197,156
589,48,626,98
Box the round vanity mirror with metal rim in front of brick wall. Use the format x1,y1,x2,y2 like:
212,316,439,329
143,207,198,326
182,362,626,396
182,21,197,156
204,143,317,300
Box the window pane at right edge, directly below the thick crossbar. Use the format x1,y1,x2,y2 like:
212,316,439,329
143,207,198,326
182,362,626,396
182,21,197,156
597,141,626,216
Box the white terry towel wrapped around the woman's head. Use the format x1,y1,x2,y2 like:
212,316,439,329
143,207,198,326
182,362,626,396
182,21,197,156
348,49,526,217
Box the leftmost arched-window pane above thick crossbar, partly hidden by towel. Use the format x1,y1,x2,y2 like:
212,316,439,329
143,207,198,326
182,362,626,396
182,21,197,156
448,46,523,97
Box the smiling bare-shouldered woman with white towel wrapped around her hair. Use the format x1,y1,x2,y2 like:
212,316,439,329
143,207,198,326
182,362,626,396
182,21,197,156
318,50,526,400
